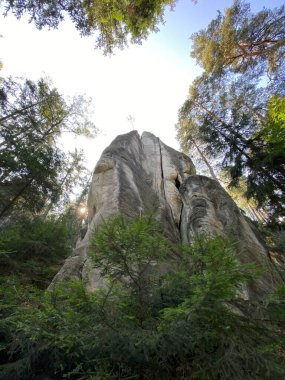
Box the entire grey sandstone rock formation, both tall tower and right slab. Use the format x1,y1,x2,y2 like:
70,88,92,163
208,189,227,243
48,131,275,297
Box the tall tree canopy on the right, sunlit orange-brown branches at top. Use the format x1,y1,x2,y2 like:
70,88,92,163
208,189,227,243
177,0,285,221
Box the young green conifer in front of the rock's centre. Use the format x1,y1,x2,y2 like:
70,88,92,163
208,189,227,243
91,216,169,325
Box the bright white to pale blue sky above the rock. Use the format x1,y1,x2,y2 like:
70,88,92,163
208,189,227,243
0,0,284,170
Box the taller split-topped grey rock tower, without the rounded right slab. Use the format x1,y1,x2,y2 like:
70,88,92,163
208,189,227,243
51,131,195,289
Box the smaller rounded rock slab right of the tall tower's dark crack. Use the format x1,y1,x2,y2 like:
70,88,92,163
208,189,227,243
180,175,276,298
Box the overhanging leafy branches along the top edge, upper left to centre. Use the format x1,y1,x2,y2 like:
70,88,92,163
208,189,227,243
3,0,175,54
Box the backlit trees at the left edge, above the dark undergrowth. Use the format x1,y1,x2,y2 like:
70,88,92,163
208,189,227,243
0,78,97,217
